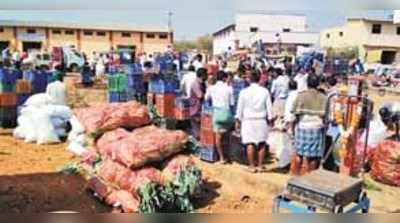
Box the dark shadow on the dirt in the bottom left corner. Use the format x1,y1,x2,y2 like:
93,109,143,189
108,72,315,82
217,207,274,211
0,173,111,213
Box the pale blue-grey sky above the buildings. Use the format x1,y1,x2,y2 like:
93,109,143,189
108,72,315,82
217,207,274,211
0,0,400,40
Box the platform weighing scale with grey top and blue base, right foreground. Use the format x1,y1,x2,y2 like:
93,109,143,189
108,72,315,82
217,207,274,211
273,93,372,214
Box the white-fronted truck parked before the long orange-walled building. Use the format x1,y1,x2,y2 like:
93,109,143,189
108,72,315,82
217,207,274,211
52,46,85,72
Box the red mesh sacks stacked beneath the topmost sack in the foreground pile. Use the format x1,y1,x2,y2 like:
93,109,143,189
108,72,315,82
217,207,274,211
82,126,194,213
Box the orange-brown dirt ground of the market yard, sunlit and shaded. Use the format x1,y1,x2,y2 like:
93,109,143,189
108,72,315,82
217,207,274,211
0,85,400,213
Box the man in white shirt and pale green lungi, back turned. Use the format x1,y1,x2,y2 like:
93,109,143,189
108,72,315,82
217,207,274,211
205,71,235,164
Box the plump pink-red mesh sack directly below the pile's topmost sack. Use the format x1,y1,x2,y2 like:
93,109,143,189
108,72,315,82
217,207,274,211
97,126,188,168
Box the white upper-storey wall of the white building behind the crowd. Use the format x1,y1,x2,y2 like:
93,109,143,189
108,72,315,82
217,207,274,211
236,14,307,32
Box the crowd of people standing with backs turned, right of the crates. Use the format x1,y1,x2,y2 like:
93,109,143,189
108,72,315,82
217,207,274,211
181,53,354,175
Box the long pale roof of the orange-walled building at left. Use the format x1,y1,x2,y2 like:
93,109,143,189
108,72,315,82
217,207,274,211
0,20,169,32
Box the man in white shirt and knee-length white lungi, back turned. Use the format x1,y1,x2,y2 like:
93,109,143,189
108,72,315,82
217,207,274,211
236,71,272,173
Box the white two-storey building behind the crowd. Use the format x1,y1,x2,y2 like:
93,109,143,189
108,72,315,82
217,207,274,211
213,14,319,55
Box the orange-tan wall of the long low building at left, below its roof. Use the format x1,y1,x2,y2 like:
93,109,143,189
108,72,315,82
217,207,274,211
0,25,173,55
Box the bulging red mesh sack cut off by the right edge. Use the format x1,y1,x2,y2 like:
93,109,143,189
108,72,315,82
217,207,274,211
371,140,400,187
